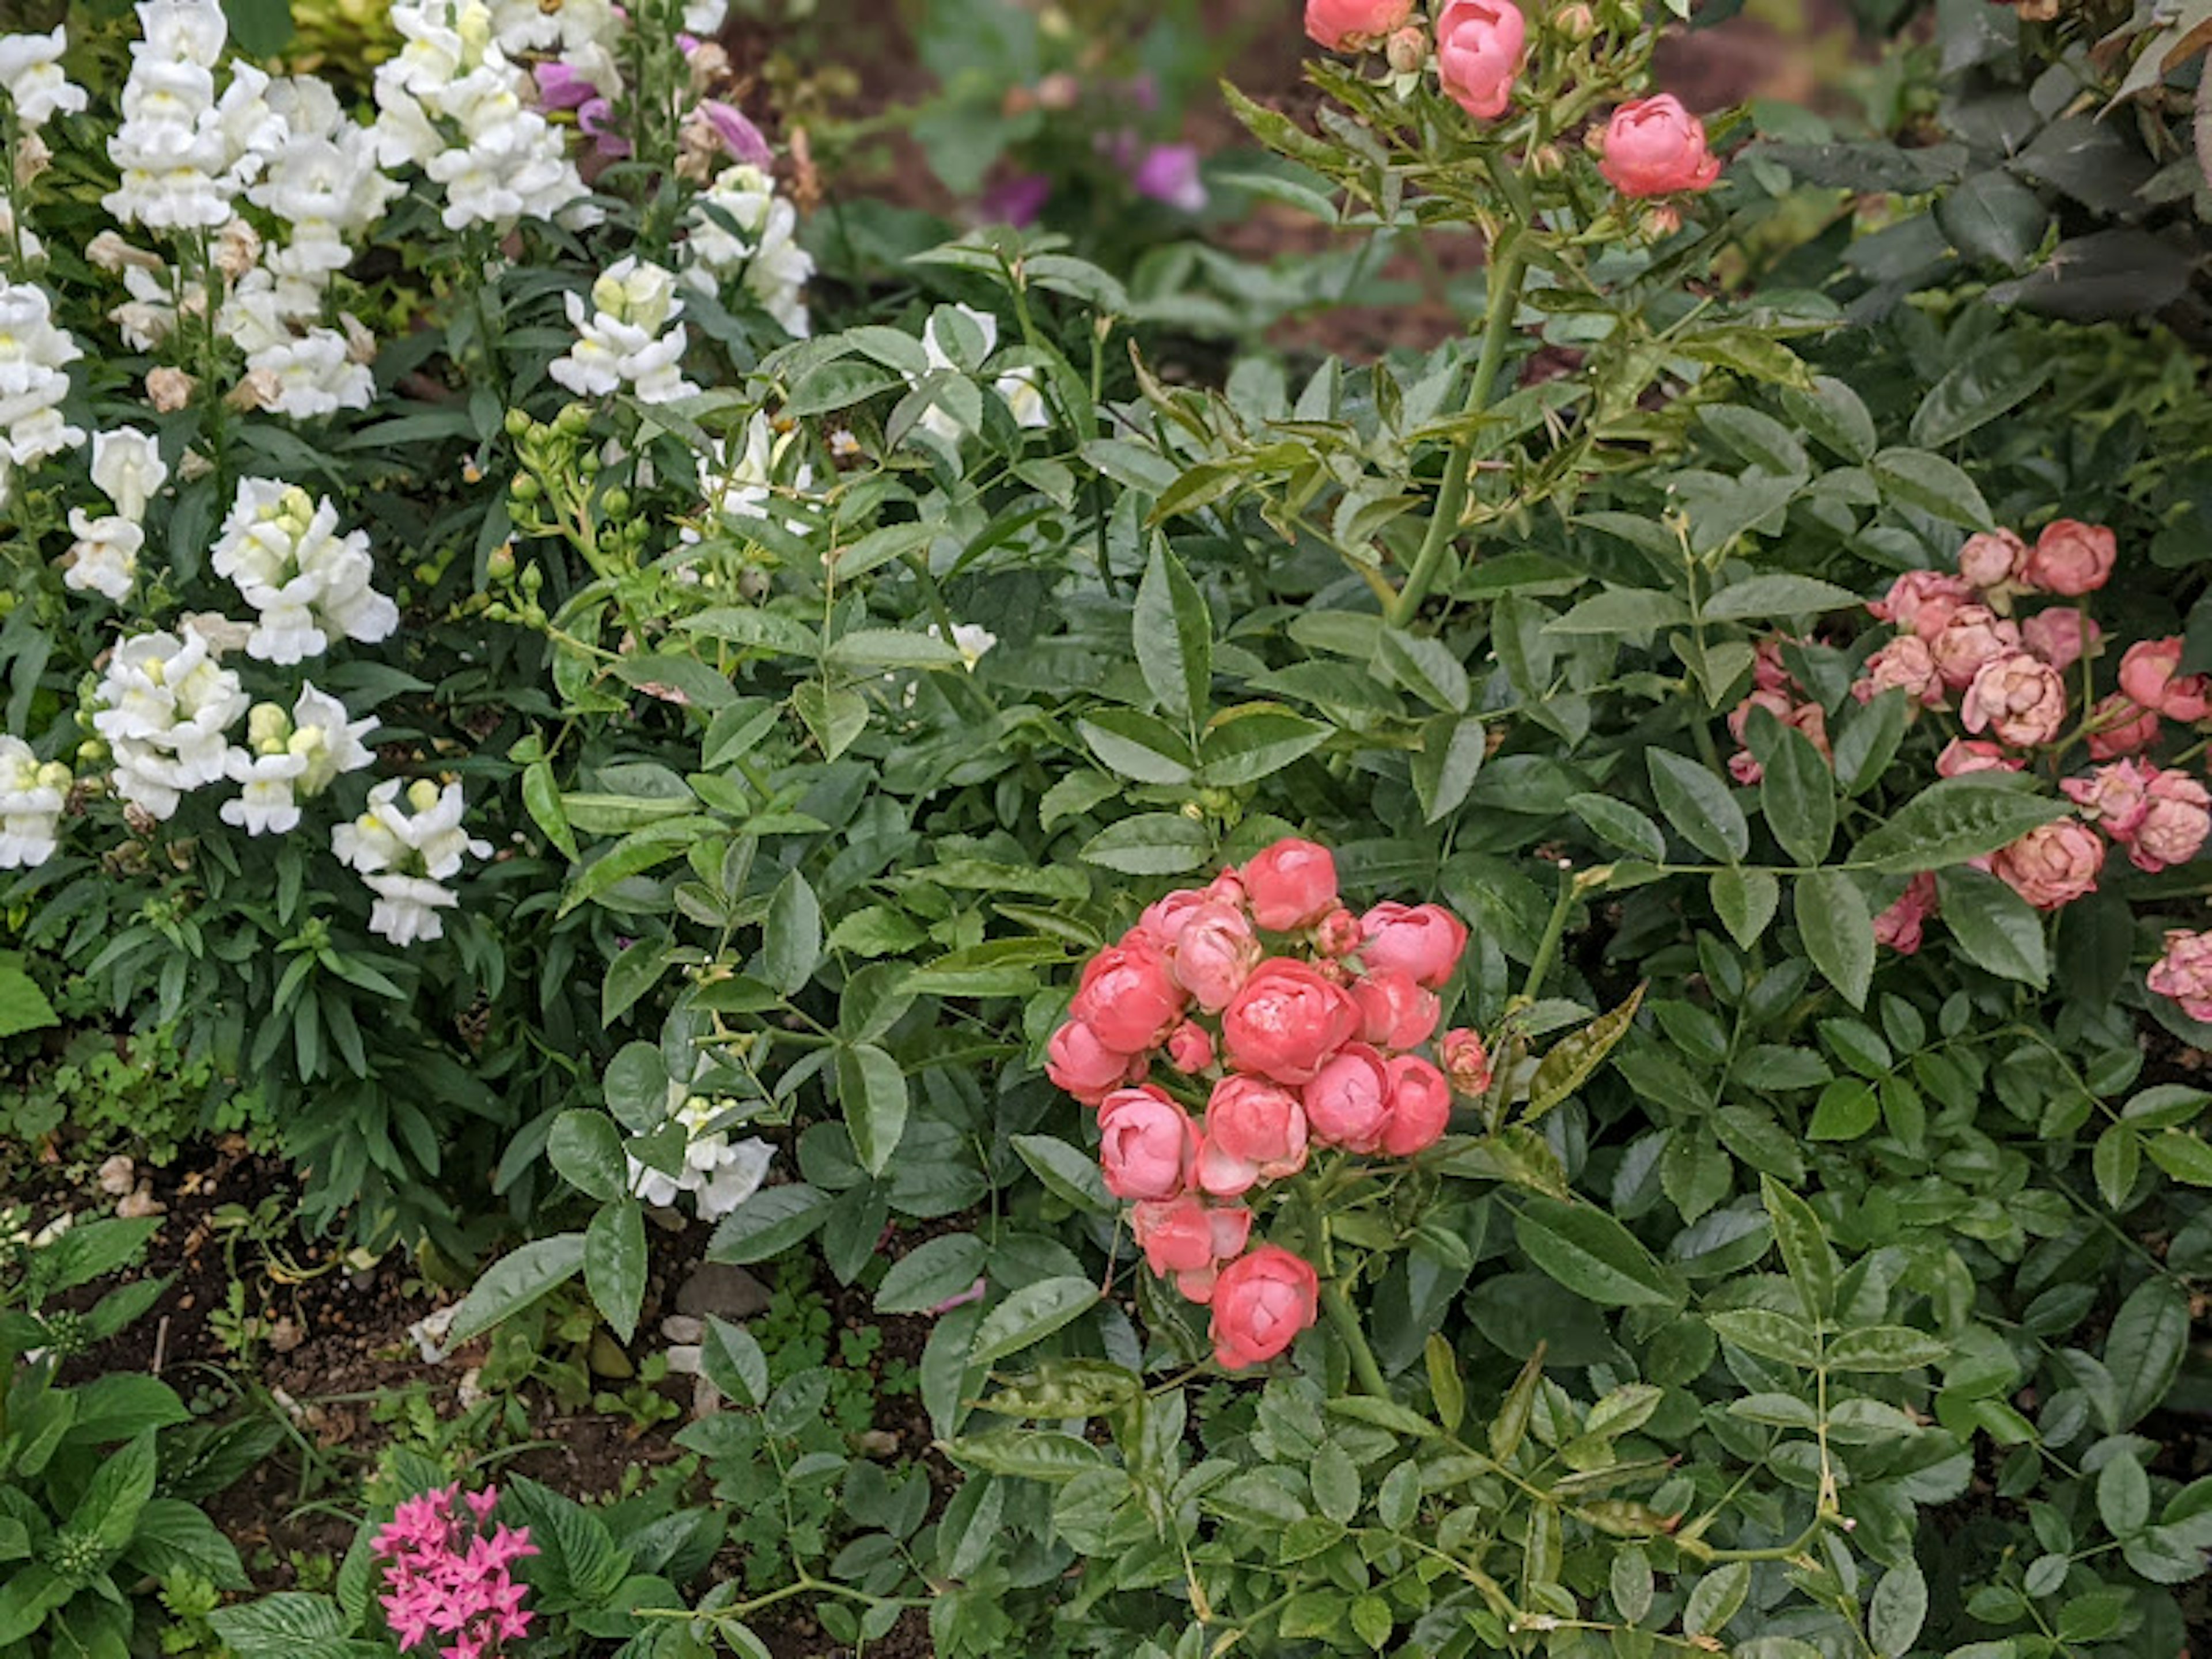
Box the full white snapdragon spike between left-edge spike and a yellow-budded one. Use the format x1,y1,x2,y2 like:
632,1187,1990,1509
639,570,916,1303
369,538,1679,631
93,626,245,819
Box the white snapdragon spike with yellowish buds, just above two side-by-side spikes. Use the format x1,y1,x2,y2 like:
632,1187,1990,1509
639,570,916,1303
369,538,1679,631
208,478,400,664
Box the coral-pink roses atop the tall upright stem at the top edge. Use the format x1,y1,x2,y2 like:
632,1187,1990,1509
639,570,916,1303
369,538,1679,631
1305,0,1721,199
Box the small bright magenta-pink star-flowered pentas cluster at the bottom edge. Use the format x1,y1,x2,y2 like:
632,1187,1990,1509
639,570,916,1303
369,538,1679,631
369,1484,537,1659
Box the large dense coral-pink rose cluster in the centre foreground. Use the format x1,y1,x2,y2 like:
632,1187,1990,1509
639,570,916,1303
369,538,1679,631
1046,840,1488,1369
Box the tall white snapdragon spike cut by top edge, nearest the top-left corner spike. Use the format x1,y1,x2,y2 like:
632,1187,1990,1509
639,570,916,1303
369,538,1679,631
102,0,283,230
